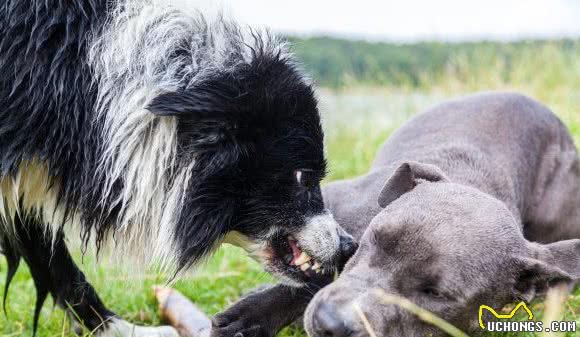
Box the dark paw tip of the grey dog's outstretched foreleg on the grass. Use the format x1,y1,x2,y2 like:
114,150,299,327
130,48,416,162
211,307,275,337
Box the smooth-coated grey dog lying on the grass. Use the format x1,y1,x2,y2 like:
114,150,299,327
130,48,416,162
216,93,580,337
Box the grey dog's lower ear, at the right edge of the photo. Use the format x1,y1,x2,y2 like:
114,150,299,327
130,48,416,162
514,239,580,301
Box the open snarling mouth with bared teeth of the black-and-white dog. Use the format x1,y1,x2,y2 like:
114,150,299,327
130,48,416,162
270,235,334,283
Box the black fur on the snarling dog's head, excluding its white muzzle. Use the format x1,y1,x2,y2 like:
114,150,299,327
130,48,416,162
149,55,325,267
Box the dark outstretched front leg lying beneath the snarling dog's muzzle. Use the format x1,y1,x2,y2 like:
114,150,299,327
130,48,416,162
211,279,331,337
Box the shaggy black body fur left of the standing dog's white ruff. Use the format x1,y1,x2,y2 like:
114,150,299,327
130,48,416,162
0,0,114,242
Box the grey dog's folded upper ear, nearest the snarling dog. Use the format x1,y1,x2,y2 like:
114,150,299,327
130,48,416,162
379,161,448,208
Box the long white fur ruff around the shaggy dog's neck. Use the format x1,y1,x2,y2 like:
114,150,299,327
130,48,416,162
88,0,284,266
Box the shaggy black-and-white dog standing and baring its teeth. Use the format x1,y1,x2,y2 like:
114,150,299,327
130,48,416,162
0,0,352,336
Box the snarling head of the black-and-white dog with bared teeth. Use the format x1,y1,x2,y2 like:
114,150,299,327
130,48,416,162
148,51,353,283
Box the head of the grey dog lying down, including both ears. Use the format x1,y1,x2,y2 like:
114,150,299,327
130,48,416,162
305,162,580,337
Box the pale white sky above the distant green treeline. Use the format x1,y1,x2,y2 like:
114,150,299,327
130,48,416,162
182,0,580,42
